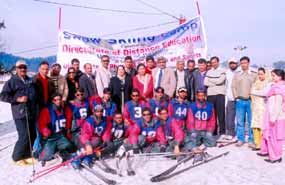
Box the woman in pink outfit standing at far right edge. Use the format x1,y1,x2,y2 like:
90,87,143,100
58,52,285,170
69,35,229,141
257,69,285,163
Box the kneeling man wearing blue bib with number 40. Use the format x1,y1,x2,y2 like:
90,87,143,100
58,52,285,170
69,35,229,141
185,90,216,150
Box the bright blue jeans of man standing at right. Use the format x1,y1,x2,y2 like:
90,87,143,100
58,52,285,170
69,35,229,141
236,99,253,143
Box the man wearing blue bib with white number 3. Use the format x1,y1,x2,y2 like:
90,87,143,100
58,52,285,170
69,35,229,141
123,88,147,125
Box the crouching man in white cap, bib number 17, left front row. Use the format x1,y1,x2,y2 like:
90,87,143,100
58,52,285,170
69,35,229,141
80,105,112,166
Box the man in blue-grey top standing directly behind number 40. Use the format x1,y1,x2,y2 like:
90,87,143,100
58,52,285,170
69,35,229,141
193,58,207,94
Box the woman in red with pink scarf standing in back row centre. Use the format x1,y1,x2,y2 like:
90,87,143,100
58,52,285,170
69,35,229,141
133,64,153,100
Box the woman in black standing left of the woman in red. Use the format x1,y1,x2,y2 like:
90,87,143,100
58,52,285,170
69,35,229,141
109,65,132,112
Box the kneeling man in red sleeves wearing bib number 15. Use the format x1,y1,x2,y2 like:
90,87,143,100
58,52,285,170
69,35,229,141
38,94,72,166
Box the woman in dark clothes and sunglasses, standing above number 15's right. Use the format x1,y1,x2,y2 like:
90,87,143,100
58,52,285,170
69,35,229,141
66,67,79,103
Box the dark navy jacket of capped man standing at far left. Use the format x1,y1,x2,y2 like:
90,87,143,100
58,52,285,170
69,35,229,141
0,75,36,120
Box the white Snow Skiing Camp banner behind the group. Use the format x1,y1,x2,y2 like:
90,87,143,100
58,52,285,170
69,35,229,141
57,17,207,71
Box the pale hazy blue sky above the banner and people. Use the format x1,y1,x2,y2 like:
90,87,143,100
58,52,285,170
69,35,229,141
0,0,285,64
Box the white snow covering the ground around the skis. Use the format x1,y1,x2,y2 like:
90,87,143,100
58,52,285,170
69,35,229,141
0,85,285,185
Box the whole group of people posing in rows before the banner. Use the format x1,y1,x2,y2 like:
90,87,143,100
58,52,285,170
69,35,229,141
0,55,285,168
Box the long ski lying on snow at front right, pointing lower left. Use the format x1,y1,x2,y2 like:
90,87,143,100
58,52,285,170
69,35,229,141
151,151,230,182
